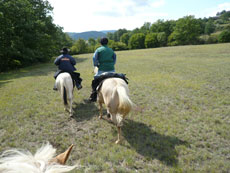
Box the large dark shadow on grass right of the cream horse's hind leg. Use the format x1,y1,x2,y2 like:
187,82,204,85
122,120,189,166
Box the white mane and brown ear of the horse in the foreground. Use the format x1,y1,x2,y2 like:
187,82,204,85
0,143,77,173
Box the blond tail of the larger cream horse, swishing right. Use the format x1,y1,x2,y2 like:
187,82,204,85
116,86,133,116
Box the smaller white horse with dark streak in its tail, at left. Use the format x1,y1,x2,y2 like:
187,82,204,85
56,72,74,116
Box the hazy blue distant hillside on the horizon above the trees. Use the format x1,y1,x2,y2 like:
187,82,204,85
67,30,116,40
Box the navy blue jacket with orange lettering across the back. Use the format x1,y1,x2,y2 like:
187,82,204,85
54,54,77,72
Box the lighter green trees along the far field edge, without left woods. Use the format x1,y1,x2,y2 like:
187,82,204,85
71,10,230,54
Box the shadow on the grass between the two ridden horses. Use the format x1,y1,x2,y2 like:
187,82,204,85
73,101,98,122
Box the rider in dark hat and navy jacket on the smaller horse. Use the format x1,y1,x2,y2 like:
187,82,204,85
53,47,82,90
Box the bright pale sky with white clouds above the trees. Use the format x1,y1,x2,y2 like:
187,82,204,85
48,0,230,33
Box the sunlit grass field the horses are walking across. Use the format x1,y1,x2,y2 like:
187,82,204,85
0,44,230,173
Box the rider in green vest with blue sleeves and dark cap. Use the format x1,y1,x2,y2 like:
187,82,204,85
89,37,116,102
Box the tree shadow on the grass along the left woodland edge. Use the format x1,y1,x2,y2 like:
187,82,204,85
0,58,87,87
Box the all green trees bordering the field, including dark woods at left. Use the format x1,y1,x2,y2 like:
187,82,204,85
0,0,230,72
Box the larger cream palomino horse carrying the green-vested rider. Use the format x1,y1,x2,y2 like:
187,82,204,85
97,78,133,144
